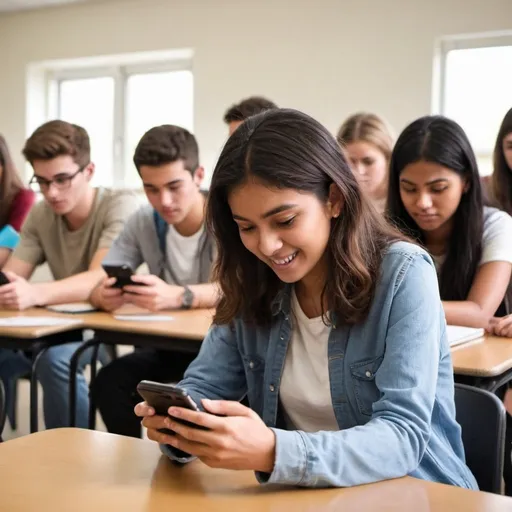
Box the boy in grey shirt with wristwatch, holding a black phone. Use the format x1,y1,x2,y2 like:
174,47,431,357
91,125,218,437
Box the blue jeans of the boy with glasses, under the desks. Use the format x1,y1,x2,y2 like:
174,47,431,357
0,342,106,428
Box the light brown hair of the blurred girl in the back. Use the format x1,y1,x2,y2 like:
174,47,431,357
336,112,394,162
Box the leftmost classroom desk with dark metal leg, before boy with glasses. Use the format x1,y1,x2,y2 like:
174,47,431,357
0,308,84,432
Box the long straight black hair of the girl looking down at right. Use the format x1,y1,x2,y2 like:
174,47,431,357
388,116,483,300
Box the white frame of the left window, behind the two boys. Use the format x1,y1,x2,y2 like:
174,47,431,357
44,50,193,188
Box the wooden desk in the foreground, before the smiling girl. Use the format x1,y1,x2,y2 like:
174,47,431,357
0,429,512,512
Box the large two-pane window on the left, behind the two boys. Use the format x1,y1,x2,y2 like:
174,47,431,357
48,61,194,188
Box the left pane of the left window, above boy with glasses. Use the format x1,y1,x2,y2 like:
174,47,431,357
59,77,114,187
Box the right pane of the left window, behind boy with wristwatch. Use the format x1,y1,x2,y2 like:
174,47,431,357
125,71,194,188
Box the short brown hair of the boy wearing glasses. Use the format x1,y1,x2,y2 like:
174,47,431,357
22,120,91,168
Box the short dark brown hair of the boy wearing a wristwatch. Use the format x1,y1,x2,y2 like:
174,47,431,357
133,124,199,174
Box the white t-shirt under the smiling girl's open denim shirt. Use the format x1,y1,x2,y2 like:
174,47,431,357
279,291,339,432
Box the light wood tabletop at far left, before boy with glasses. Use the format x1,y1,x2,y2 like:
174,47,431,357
0,308,84,339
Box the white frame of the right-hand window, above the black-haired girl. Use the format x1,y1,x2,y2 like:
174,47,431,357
432,30,512,165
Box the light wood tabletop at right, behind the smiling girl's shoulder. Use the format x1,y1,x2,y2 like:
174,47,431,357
452,336,512,377
